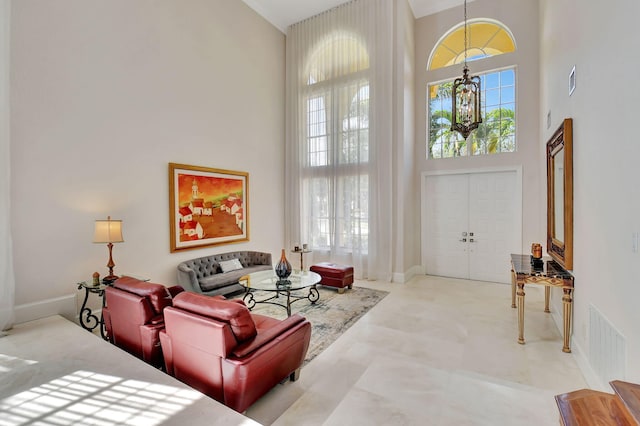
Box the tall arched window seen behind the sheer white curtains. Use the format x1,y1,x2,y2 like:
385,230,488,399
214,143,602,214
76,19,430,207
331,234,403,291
302,44,369,253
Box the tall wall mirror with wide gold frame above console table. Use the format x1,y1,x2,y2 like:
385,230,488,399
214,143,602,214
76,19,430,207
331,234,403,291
547,118,573,269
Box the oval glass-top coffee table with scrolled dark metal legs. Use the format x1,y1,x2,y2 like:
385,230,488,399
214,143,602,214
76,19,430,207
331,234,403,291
239,271,321,316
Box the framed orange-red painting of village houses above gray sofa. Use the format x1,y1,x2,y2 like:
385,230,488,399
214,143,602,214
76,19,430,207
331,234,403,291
169,163,249,253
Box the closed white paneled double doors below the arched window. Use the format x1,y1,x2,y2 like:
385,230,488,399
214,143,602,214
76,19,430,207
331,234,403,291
423,171,522,283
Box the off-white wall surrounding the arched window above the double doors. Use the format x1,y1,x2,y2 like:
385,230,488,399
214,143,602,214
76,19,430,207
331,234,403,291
415,0,546,255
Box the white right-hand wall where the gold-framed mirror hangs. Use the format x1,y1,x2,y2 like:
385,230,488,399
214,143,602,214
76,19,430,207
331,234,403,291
540,0,640,391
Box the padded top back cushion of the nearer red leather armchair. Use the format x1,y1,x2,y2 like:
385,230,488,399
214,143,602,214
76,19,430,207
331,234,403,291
173,292,257,343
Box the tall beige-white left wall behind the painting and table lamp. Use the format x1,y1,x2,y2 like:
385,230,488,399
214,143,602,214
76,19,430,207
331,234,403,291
11,0,285,312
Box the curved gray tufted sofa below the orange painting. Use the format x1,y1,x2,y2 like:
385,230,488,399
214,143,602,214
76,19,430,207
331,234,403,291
178,251,272,296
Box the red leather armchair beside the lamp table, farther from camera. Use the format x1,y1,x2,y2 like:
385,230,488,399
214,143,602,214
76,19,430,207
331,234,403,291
102,277,182,367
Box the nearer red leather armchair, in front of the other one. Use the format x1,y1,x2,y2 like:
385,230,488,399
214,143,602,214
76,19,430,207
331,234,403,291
160,292,311,412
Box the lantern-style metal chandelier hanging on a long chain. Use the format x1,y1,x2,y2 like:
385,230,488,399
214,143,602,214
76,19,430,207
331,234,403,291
451,0,482,139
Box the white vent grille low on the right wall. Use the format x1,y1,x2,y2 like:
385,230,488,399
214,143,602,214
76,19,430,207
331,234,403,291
589,305,627,384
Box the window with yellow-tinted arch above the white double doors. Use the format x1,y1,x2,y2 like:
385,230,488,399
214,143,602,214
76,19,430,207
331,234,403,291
427,20,516,158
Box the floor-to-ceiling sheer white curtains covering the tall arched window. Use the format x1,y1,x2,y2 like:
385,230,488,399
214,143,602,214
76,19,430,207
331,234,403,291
284,0,395,281
